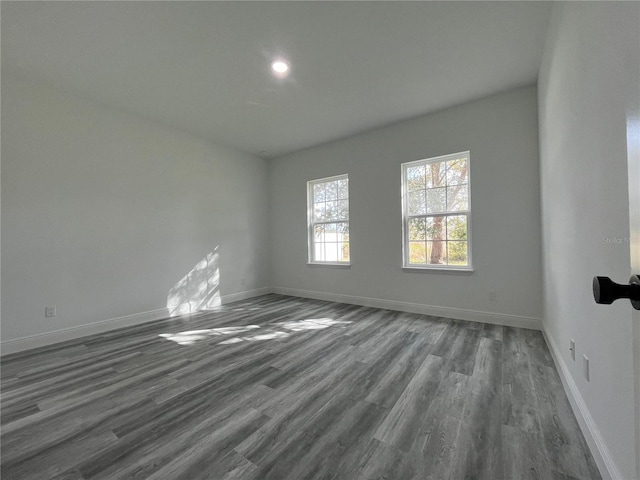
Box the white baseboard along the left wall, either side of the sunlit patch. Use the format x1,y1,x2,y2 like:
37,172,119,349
0,287,271,355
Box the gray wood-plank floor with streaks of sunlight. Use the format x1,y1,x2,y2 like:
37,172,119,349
1,295,600,480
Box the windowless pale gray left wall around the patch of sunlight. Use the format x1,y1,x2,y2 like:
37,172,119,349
2,73,269,343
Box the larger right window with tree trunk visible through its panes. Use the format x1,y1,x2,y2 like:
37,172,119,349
402,152,471,270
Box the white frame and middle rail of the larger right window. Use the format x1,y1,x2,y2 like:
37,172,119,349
400,150,474,273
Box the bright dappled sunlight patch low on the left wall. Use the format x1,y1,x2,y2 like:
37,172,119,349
167,245,222,317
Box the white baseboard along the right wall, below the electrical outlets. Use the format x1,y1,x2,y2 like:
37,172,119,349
542,327,622,480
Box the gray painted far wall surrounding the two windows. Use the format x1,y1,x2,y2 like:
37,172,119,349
270,86,542,325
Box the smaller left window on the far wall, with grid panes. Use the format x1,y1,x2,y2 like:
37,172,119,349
307,175,349,265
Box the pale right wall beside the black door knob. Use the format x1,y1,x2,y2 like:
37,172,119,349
539,2,640,479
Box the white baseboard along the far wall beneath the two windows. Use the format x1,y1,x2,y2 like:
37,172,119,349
272,287,542,330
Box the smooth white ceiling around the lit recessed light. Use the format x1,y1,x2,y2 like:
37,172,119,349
1,1,550,158
